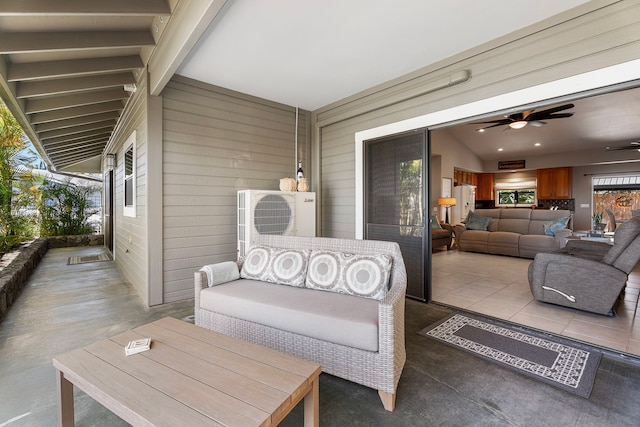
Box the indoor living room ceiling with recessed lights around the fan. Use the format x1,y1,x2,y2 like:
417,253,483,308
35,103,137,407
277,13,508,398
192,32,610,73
436,88,640,166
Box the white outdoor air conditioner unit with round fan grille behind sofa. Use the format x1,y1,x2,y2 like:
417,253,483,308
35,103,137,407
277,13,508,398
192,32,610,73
238,190,316,258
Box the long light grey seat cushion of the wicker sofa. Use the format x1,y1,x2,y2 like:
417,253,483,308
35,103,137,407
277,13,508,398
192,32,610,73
200,279,379,351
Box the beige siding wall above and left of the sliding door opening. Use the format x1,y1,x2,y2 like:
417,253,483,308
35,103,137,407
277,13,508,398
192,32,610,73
313,0,640,238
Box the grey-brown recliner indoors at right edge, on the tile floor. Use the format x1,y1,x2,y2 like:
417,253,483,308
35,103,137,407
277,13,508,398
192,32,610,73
529,217,640,316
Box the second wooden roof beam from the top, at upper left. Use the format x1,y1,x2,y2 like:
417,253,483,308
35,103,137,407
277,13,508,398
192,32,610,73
0,31,155,54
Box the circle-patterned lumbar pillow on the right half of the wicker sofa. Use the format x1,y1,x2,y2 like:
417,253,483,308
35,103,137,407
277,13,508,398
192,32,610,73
305,250,392,300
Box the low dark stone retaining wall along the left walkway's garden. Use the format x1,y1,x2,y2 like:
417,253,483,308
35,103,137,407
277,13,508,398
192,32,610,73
0,234,104,320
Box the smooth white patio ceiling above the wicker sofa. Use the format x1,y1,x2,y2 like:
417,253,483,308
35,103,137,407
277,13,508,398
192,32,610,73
178,0,586,111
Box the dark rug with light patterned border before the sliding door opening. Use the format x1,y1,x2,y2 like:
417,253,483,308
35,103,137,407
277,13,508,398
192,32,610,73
418,313,602,398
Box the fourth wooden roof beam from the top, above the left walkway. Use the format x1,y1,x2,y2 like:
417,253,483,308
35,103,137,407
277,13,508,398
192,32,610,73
16,72,136,98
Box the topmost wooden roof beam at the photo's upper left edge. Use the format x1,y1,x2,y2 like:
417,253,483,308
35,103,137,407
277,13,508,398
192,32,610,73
0,0,171,16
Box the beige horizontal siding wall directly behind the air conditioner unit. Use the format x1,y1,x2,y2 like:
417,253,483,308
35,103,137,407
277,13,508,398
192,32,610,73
163,76,309,302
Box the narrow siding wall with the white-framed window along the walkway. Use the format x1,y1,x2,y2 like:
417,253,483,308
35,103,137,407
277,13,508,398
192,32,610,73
107,73,149,304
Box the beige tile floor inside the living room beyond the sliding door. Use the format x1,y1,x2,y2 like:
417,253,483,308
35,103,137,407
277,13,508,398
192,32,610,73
432,250,640,356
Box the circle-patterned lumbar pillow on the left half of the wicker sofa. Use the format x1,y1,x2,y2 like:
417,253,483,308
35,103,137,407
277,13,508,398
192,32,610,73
240,246,311,287
